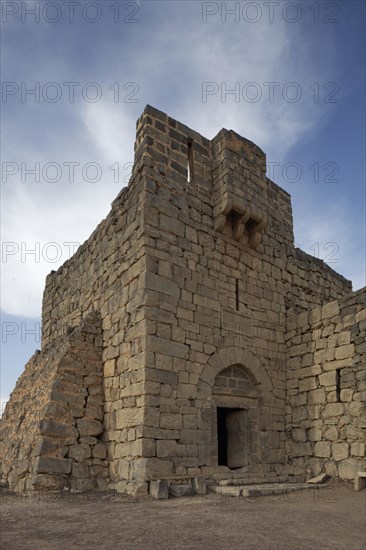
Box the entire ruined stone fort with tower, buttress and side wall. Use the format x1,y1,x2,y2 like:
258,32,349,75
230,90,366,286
0,106,366,496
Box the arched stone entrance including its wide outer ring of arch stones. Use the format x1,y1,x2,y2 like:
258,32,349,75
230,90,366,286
197,346,274,468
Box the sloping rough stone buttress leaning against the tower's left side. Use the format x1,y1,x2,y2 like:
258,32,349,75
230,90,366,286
0,314,108,492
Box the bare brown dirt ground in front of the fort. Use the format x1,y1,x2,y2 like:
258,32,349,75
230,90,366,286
0,482,366,550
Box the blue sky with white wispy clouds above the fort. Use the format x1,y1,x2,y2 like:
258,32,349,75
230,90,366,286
0,0,365,412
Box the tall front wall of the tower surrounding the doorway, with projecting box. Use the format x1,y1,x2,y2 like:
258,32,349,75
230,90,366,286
121,104,350,486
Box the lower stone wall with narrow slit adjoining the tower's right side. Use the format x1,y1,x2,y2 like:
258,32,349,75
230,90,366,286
286,289,366,479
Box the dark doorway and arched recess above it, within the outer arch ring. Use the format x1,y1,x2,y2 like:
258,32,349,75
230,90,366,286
212,364,259,469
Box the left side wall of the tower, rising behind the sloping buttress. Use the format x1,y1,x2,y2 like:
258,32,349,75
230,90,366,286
38,144,149,494
